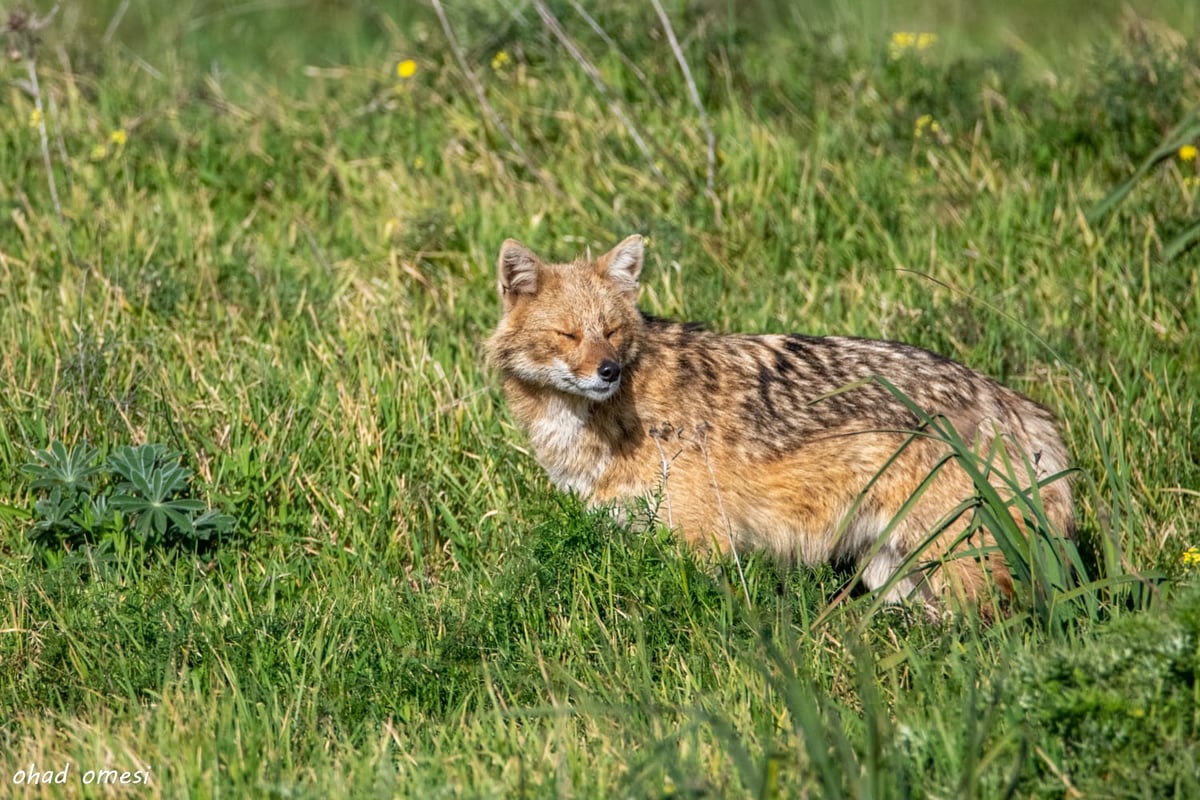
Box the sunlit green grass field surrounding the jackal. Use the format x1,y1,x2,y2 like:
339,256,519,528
0,0,1200,798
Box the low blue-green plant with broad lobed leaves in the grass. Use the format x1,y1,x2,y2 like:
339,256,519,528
22,441,234,548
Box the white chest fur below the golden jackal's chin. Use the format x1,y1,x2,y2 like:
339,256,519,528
529,396,612,497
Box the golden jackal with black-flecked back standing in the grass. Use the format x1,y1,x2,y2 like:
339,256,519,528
488,236,1074,602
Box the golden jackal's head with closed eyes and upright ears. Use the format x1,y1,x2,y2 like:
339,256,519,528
488,235,642,402
